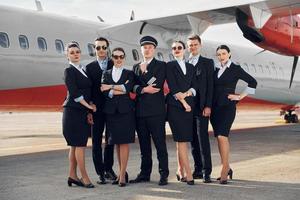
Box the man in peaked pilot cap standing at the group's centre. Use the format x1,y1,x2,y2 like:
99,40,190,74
130,36,169,185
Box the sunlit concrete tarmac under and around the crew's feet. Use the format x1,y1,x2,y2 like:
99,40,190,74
0,110,300,200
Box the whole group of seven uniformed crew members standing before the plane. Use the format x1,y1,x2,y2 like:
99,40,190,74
63,35,257,188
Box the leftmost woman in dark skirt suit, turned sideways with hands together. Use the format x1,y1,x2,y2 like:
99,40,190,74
62,42,96,188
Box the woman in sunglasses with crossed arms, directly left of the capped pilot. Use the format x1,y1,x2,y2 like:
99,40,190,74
101,48,135,187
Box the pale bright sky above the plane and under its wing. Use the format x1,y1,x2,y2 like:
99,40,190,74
0,0,253,46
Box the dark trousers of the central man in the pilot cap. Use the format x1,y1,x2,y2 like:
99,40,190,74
136,115,169,178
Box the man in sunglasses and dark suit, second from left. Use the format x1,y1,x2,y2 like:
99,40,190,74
86,37,117,184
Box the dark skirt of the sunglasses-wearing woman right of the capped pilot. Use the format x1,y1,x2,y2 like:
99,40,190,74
167,105,193,142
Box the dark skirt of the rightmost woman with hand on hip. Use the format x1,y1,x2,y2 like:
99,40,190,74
210,104,236,137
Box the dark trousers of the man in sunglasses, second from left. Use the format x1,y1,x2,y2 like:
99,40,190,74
92,112,114,175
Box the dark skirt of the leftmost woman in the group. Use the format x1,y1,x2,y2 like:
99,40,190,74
62,107,91,147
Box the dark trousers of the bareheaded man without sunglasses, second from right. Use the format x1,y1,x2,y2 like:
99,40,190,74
191,116,212,175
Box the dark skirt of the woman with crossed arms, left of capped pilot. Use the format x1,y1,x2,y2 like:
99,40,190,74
106,111,135,144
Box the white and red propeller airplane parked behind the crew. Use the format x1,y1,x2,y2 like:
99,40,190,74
0,0,300,122
